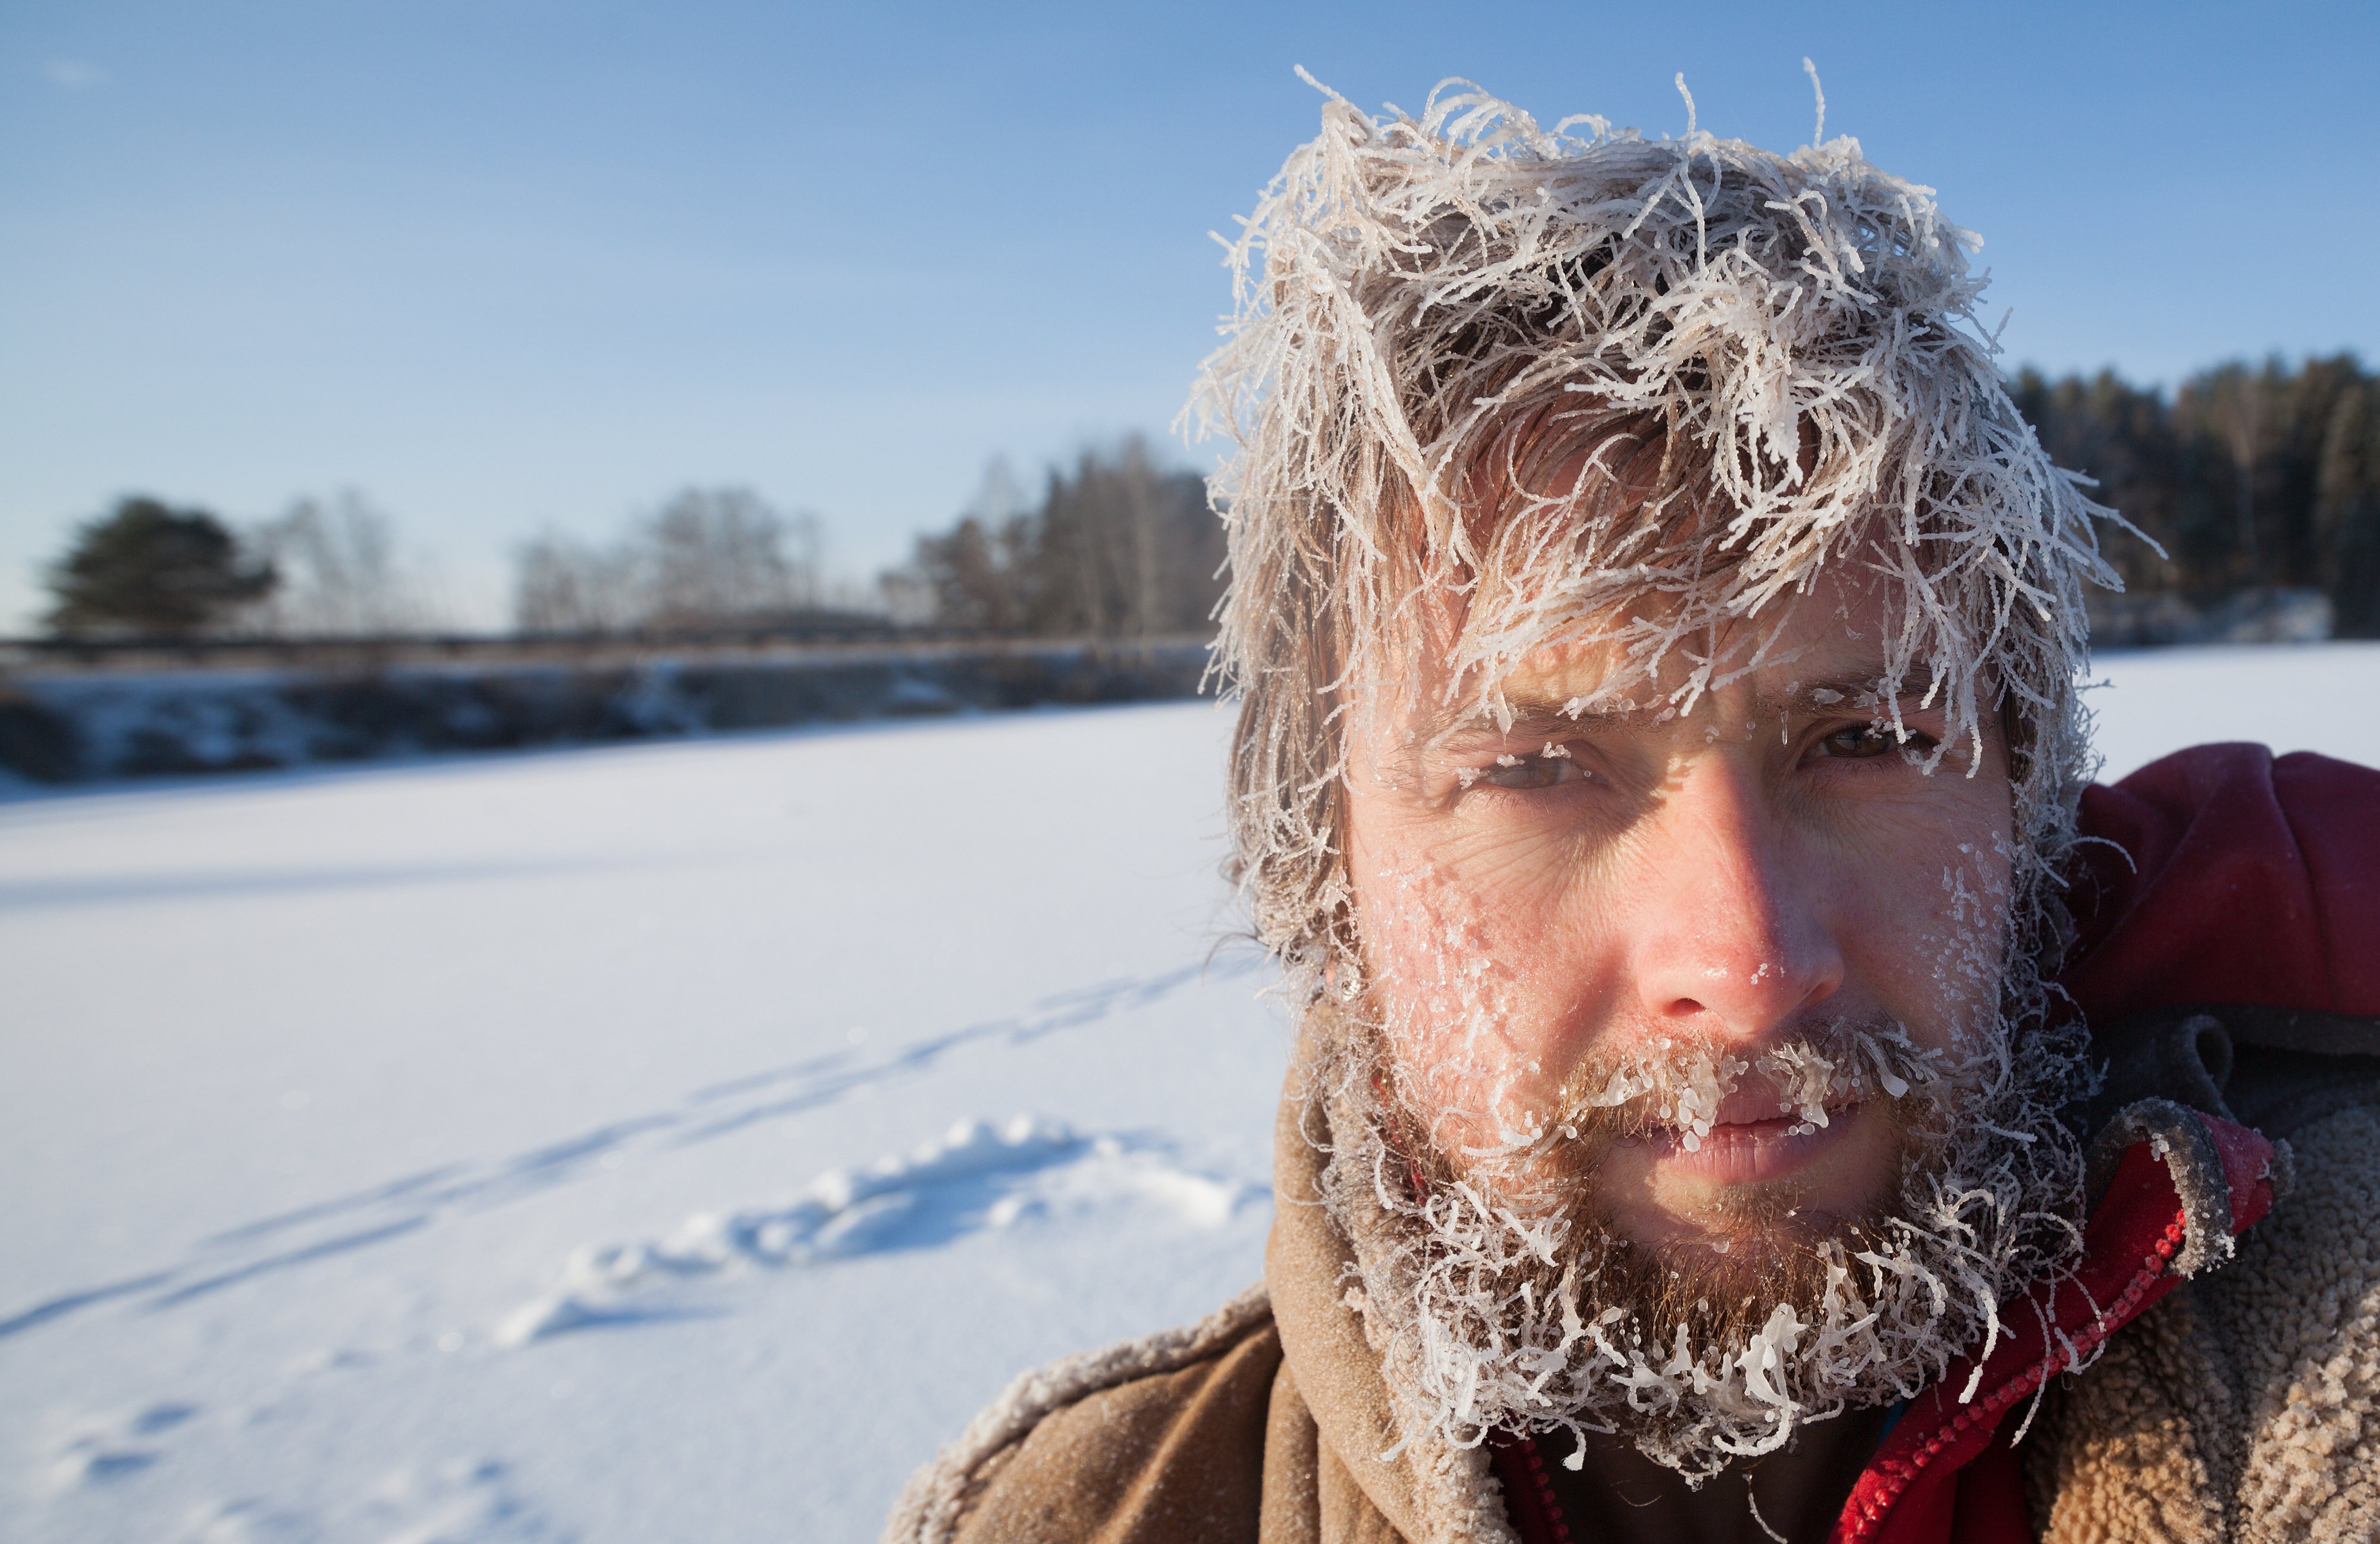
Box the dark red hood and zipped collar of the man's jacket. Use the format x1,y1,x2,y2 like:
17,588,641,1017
1497,745,2380,1544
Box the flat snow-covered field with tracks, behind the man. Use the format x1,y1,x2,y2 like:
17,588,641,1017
0,645,2380,1544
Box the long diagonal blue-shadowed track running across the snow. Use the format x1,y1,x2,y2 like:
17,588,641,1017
0,952,1266,1339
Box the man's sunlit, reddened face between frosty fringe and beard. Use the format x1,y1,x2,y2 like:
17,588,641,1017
1347,583,2011,1273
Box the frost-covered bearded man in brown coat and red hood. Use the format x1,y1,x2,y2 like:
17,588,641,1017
888,90,2380,1542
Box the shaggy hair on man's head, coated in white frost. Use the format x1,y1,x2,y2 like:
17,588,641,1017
1190,81,2116,994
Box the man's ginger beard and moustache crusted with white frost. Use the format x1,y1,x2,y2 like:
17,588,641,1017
1309,990,2085,1485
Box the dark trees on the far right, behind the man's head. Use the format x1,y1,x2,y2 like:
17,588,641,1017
2014,354,2380,638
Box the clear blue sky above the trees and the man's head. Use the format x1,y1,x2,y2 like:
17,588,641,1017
0,0,2380,630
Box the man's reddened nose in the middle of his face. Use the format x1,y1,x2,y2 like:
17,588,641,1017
1632,757,1845,1040
